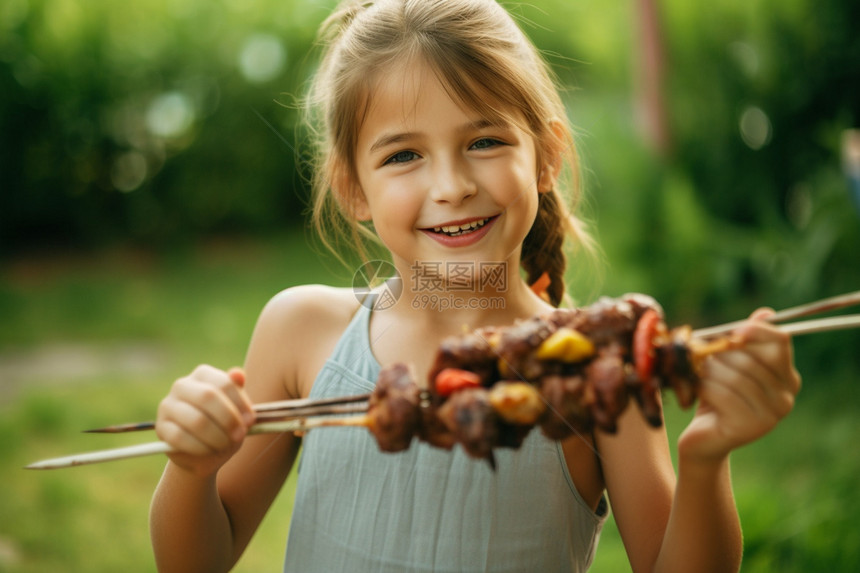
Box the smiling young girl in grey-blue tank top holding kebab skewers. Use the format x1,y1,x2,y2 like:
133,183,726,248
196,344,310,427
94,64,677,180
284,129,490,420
151,0,800,573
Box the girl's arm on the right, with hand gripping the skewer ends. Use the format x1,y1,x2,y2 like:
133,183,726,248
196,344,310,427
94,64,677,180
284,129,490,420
598,311,800,572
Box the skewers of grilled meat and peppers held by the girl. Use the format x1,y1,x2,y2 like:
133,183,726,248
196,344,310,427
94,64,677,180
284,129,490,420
27,292,860,469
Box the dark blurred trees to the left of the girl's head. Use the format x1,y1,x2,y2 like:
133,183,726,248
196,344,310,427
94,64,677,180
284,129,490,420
0,0,327,255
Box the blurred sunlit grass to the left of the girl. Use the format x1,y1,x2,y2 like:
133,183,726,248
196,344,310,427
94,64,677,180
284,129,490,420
0,235,332,573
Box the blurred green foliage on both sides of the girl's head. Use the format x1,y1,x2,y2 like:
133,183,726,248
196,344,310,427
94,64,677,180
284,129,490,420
0,0,860,321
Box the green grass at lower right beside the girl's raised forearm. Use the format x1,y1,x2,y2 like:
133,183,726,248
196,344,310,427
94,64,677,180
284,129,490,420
735,370,860,572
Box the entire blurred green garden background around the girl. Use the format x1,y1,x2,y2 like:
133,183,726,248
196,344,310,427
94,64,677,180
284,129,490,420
0,0,860,572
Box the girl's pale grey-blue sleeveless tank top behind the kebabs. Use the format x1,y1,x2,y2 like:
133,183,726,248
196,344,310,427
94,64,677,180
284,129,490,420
284,306,607,573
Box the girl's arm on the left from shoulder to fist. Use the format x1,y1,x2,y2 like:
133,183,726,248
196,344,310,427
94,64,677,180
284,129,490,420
150,287,340,573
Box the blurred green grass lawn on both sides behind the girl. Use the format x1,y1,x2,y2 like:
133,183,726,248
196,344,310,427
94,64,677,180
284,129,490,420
0,230,860,573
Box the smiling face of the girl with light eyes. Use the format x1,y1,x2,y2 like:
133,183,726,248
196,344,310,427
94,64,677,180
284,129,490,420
353,65,540,282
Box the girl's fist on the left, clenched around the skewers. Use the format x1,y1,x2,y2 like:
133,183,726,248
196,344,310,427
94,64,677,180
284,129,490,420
155,365,255,477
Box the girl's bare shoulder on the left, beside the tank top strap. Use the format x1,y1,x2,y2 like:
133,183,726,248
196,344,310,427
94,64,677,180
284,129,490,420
246,285,359,399
